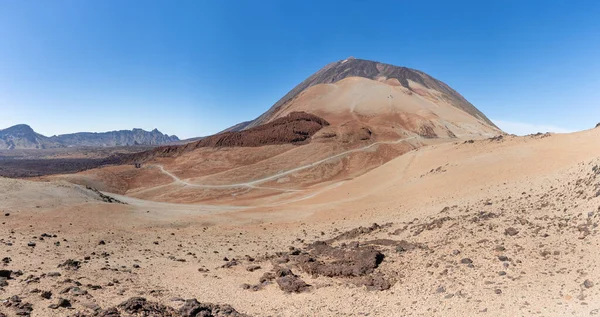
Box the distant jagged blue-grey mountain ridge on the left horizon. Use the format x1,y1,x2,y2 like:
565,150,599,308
0,124,179,150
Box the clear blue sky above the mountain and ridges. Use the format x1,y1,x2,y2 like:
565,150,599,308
0,0,600,138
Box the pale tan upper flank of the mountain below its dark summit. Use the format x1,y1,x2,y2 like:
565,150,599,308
274,77,501,137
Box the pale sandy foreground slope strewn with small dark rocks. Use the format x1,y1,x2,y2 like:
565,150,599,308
0,129,600,316
